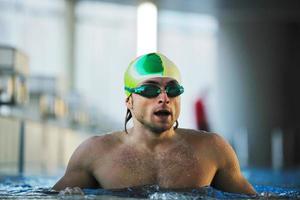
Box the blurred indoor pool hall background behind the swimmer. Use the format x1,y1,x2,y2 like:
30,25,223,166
0,0,300,174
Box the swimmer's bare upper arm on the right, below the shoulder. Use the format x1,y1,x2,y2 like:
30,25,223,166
212,135,256,195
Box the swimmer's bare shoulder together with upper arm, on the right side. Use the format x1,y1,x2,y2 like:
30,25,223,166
176,129,256,194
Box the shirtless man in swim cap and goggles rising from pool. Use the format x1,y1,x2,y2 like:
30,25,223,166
53,53,256,195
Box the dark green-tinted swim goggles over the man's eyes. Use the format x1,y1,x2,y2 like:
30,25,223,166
125,84,184,98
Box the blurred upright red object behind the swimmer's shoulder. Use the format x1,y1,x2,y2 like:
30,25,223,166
195,98,209,131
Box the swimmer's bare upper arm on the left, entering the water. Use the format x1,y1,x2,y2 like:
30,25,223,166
52,138,99,191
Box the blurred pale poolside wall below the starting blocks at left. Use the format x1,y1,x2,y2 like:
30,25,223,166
0,117,91,175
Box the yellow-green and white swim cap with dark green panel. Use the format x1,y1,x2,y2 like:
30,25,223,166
124,53,181,96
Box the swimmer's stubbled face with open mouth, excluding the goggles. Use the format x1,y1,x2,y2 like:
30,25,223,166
126,77,180,133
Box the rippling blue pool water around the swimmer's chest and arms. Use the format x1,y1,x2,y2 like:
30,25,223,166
0,169,300,199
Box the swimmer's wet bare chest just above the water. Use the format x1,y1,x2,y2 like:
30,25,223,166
94,146,215,188
